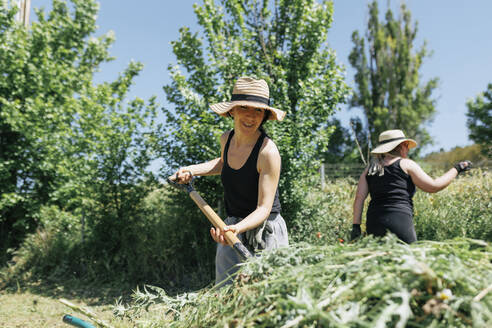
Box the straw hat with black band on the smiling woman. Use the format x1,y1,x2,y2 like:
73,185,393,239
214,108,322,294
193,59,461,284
210,77,285,121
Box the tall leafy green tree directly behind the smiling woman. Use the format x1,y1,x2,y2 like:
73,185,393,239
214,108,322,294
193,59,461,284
163,0,347,219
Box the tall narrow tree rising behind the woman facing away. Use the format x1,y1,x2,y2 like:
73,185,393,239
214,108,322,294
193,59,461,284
349,1,438,151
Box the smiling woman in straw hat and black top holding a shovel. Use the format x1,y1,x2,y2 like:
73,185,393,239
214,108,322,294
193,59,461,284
171,77,288,284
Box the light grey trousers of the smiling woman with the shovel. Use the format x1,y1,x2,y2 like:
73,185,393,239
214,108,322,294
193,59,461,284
215,213,289,286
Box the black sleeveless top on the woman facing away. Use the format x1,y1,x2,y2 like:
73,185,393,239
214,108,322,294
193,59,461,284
366,159,415,216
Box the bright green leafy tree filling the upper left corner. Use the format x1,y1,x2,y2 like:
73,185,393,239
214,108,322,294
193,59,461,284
0,0,156,262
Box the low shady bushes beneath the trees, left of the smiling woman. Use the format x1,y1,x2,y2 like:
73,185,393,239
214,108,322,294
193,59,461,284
2,187,215,291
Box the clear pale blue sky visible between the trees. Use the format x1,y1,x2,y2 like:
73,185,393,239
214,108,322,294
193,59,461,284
31,0,492,153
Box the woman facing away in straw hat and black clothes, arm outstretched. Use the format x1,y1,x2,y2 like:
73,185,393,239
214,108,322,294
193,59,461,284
351,130,471,243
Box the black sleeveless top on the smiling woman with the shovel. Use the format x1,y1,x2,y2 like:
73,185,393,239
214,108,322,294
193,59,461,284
220,130,281,218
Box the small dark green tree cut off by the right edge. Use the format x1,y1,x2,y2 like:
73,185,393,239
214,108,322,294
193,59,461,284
466,83,492,154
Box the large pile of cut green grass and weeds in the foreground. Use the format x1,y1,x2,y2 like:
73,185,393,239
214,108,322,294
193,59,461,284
116,235,492,328
